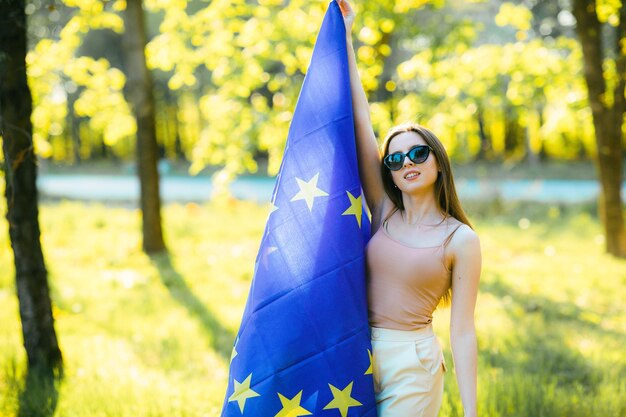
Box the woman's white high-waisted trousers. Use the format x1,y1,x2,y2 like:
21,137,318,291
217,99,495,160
370,325,446,417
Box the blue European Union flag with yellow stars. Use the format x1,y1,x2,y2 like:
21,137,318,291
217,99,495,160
221,1,376,417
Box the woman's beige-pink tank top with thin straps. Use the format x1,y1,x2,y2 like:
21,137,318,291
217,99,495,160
366,211,463,330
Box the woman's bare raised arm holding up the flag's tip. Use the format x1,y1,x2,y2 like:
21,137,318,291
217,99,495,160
337,0,385,216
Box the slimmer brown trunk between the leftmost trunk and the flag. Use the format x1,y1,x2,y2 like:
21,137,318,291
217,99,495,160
124,0,165,253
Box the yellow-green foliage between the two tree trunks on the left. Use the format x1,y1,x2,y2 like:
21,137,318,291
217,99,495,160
26,0,137,160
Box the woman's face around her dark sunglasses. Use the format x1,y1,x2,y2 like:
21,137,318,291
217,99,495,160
389,132,439,193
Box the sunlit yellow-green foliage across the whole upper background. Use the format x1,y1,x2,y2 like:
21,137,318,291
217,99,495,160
23,0,620,171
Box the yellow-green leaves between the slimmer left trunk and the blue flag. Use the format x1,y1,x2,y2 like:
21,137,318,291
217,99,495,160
141,0,326,177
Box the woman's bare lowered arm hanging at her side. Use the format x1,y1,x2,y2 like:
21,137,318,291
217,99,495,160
448,226,481,417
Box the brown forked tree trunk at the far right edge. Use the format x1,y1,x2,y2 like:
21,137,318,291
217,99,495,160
573,0,626,257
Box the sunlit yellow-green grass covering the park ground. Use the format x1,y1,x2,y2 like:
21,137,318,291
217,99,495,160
0,195,626,417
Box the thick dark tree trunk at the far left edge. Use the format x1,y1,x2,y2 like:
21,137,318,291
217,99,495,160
0,0,62,375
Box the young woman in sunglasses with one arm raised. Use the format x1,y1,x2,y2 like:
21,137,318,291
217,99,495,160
338,0,481,417
